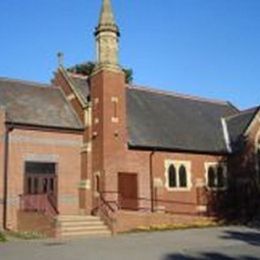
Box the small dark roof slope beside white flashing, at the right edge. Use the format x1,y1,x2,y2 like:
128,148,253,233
225,106,260,150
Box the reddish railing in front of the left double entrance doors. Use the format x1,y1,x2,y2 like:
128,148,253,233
20,194,59,218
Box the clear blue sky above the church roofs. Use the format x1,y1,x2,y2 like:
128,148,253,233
0,0,260,109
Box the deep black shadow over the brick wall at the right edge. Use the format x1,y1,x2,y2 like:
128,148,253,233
206,138,260,223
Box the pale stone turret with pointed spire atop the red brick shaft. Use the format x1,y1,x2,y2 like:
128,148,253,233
94,0,120,69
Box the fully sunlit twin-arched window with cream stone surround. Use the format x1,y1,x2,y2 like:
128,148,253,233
165,160,191,191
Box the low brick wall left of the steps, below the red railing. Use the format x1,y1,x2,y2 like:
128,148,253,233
17,211,56,237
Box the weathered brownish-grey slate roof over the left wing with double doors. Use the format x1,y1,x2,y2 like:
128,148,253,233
0,78,83,129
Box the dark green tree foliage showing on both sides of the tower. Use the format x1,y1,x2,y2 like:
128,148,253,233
67,61,133,83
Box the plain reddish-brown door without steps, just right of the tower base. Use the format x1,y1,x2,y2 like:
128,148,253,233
118,173,138,210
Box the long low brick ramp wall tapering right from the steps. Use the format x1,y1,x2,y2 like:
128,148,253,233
115,211,213,233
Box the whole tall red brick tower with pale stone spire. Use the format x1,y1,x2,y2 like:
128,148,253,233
90,0,127,203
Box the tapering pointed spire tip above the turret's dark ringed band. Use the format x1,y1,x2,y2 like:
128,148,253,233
95,0,120,36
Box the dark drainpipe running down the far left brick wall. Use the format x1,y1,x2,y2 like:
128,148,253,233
3,125,13,230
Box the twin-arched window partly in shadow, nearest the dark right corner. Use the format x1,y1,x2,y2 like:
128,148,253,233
205,163,227,189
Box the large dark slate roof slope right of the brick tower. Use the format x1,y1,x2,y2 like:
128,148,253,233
127,87,237,153
